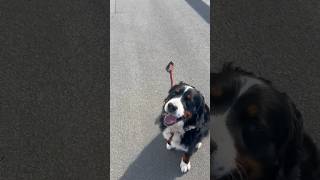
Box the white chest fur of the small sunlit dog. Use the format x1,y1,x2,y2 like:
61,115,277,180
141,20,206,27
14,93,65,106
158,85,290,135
162,121,188,152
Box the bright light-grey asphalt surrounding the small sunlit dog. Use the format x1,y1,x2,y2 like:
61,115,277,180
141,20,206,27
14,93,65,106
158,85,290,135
110,0,210,180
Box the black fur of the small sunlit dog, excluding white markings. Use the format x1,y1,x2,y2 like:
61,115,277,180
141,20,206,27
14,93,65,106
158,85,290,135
159,82,210,172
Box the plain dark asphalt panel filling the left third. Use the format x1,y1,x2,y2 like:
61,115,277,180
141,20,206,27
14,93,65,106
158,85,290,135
0,0,109,180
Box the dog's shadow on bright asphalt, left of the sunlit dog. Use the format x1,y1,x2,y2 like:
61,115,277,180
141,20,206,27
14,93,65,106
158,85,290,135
120,134,183,180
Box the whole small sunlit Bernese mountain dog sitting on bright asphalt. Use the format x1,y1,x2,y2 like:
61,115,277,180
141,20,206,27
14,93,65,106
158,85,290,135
159,82,210,173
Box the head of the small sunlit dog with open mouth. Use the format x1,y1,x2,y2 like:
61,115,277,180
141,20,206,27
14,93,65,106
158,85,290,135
161,82,209,127
